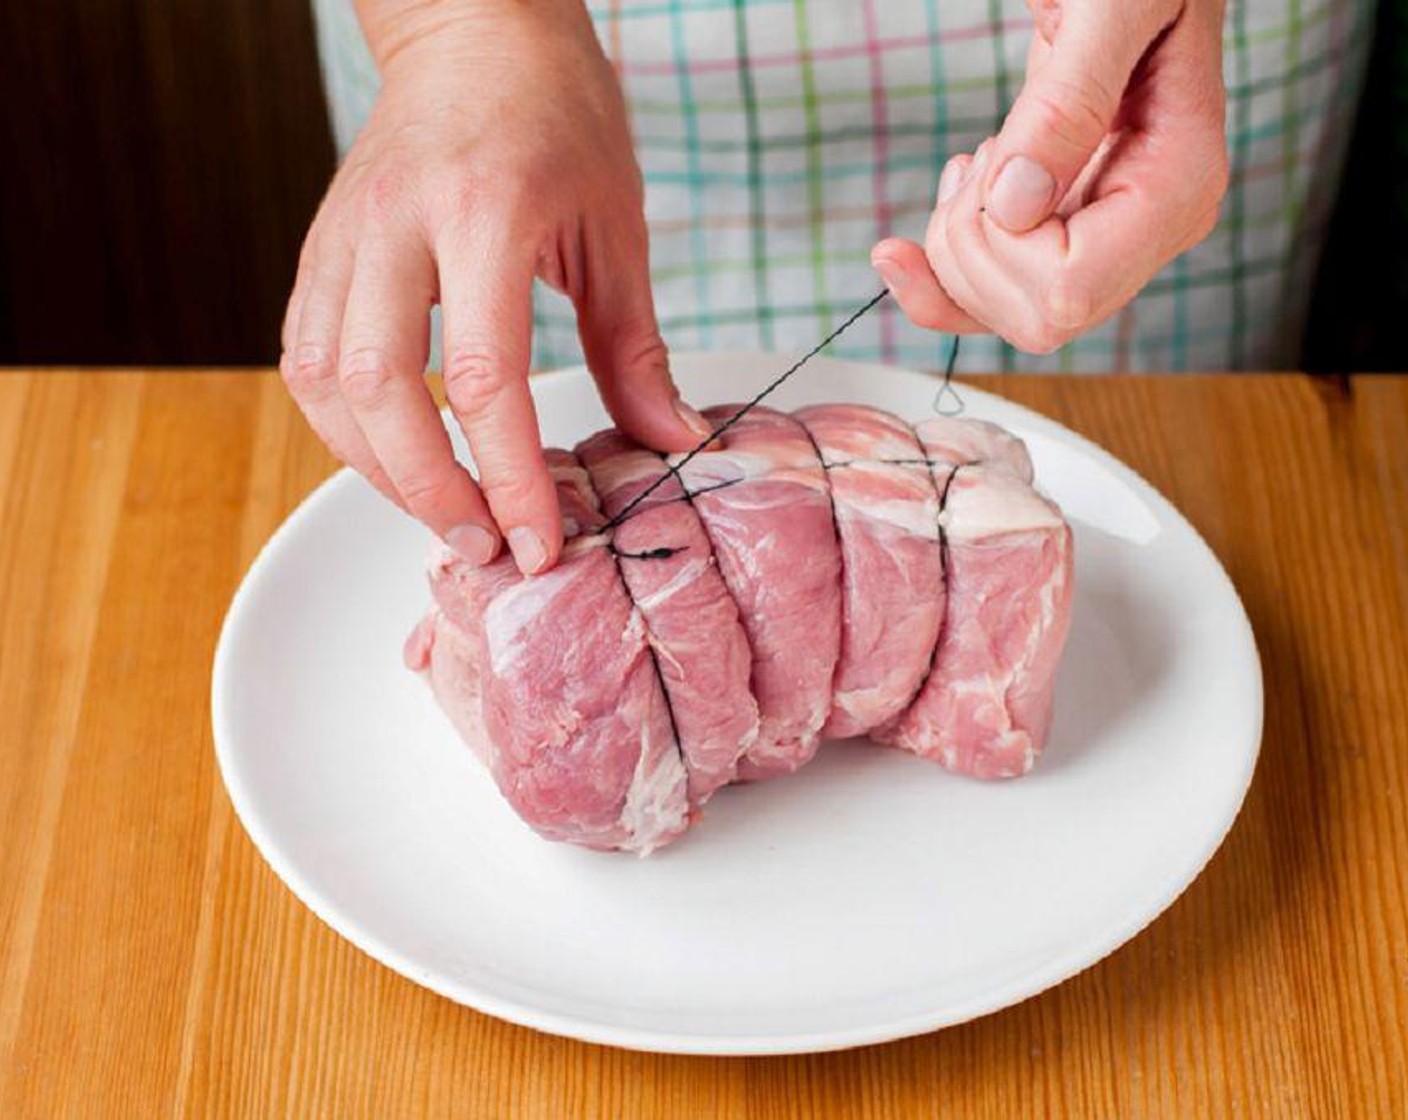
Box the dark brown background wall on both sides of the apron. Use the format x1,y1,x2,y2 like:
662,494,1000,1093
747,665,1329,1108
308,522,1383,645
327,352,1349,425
0,0,1408,371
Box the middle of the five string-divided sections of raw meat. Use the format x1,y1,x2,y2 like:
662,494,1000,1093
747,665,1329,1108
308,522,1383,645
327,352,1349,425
681,406,841,779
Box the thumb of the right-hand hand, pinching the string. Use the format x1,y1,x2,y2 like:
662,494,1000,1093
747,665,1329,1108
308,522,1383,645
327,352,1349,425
984,0,1164,232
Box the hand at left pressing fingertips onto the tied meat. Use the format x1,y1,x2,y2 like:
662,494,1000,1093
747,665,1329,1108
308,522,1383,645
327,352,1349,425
280,0,708,572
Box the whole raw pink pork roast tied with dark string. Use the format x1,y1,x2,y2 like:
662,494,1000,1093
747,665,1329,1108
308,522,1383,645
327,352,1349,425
406,404,1071,854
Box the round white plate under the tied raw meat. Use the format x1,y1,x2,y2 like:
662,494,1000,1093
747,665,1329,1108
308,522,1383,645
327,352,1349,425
213,354,1262,1054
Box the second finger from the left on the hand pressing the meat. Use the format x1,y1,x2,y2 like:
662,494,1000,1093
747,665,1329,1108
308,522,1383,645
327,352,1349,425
338,235,498,564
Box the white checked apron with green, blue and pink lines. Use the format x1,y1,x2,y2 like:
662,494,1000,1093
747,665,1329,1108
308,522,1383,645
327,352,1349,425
313,0,1374,372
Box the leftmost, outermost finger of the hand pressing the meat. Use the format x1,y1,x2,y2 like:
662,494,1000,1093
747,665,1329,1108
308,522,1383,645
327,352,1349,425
279,228,404,509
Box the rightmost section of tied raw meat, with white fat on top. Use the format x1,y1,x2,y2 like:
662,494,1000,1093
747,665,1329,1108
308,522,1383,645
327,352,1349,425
876,456,1073,778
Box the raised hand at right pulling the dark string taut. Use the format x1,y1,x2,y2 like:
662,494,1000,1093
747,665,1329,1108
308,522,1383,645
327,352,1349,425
872,0,1228,354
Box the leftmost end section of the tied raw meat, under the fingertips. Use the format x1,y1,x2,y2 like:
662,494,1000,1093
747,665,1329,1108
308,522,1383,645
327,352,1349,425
407,451,689,854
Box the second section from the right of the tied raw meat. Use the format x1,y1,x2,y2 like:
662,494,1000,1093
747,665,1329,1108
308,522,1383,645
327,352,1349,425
796,404,945,738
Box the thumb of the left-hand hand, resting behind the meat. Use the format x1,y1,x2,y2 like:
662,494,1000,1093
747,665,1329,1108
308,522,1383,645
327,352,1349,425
567,213,710,451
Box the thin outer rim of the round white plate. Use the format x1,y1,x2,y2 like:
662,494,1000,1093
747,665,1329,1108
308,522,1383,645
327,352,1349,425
210,349,1266,1057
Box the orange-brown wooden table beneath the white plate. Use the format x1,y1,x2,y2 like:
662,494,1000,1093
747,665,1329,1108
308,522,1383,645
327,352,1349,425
0,372,1408,1120
